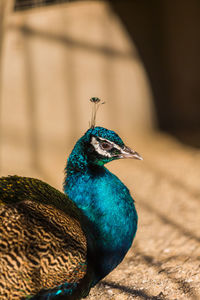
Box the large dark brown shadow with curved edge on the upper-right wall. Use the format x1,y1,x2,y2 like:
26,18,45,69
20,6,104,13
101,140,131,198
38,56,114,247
110,0,200,147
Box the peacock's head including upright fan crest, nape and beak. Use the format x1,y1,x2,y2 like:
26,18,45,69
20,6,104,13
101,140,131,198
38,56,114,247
67,97,142,173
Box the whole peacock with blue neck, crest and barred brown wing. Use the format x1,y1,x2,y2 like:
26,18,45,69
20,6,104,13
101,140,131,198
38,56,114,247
0,98,142,300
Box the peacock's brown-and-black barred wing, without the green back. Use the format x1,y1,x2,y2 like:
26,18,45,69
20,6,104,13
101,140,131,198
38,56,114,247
0,177,87,300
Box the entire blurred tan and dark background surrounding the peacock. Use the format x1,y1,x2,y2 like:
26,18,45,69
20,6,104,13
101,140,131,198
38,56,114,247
0,0,200,300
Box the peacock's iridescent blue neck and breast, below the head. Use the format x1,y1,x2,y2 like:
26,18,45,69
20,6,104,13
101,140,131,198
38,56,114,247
64,131,137,284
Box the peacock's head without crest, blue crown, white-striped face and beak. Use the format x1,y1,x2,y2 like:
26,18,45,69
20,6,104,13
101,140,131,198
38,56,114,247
83,127,142,166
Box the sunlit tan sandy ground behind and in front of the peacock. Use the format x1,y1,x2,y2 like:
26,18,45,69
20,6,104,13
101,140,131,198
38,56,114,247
0,133,200,300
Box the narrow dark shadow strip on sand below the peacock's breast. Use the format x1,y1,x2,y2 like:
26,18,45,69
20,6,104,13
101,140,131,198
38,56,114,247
98,280,167,300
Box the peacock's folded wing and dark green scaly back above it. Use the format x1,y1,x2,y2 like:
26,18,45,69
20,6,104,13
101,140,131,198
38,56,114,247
0,176,90,300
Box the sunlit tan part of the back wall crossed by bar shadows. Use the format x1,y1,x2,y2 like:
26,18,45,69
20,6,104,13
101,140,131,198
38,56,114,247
1,1,155,185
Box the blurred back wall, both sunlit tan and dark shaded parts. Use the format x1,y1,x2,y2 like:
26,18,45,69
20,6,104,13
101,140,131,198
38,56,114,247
0,0,200,182
